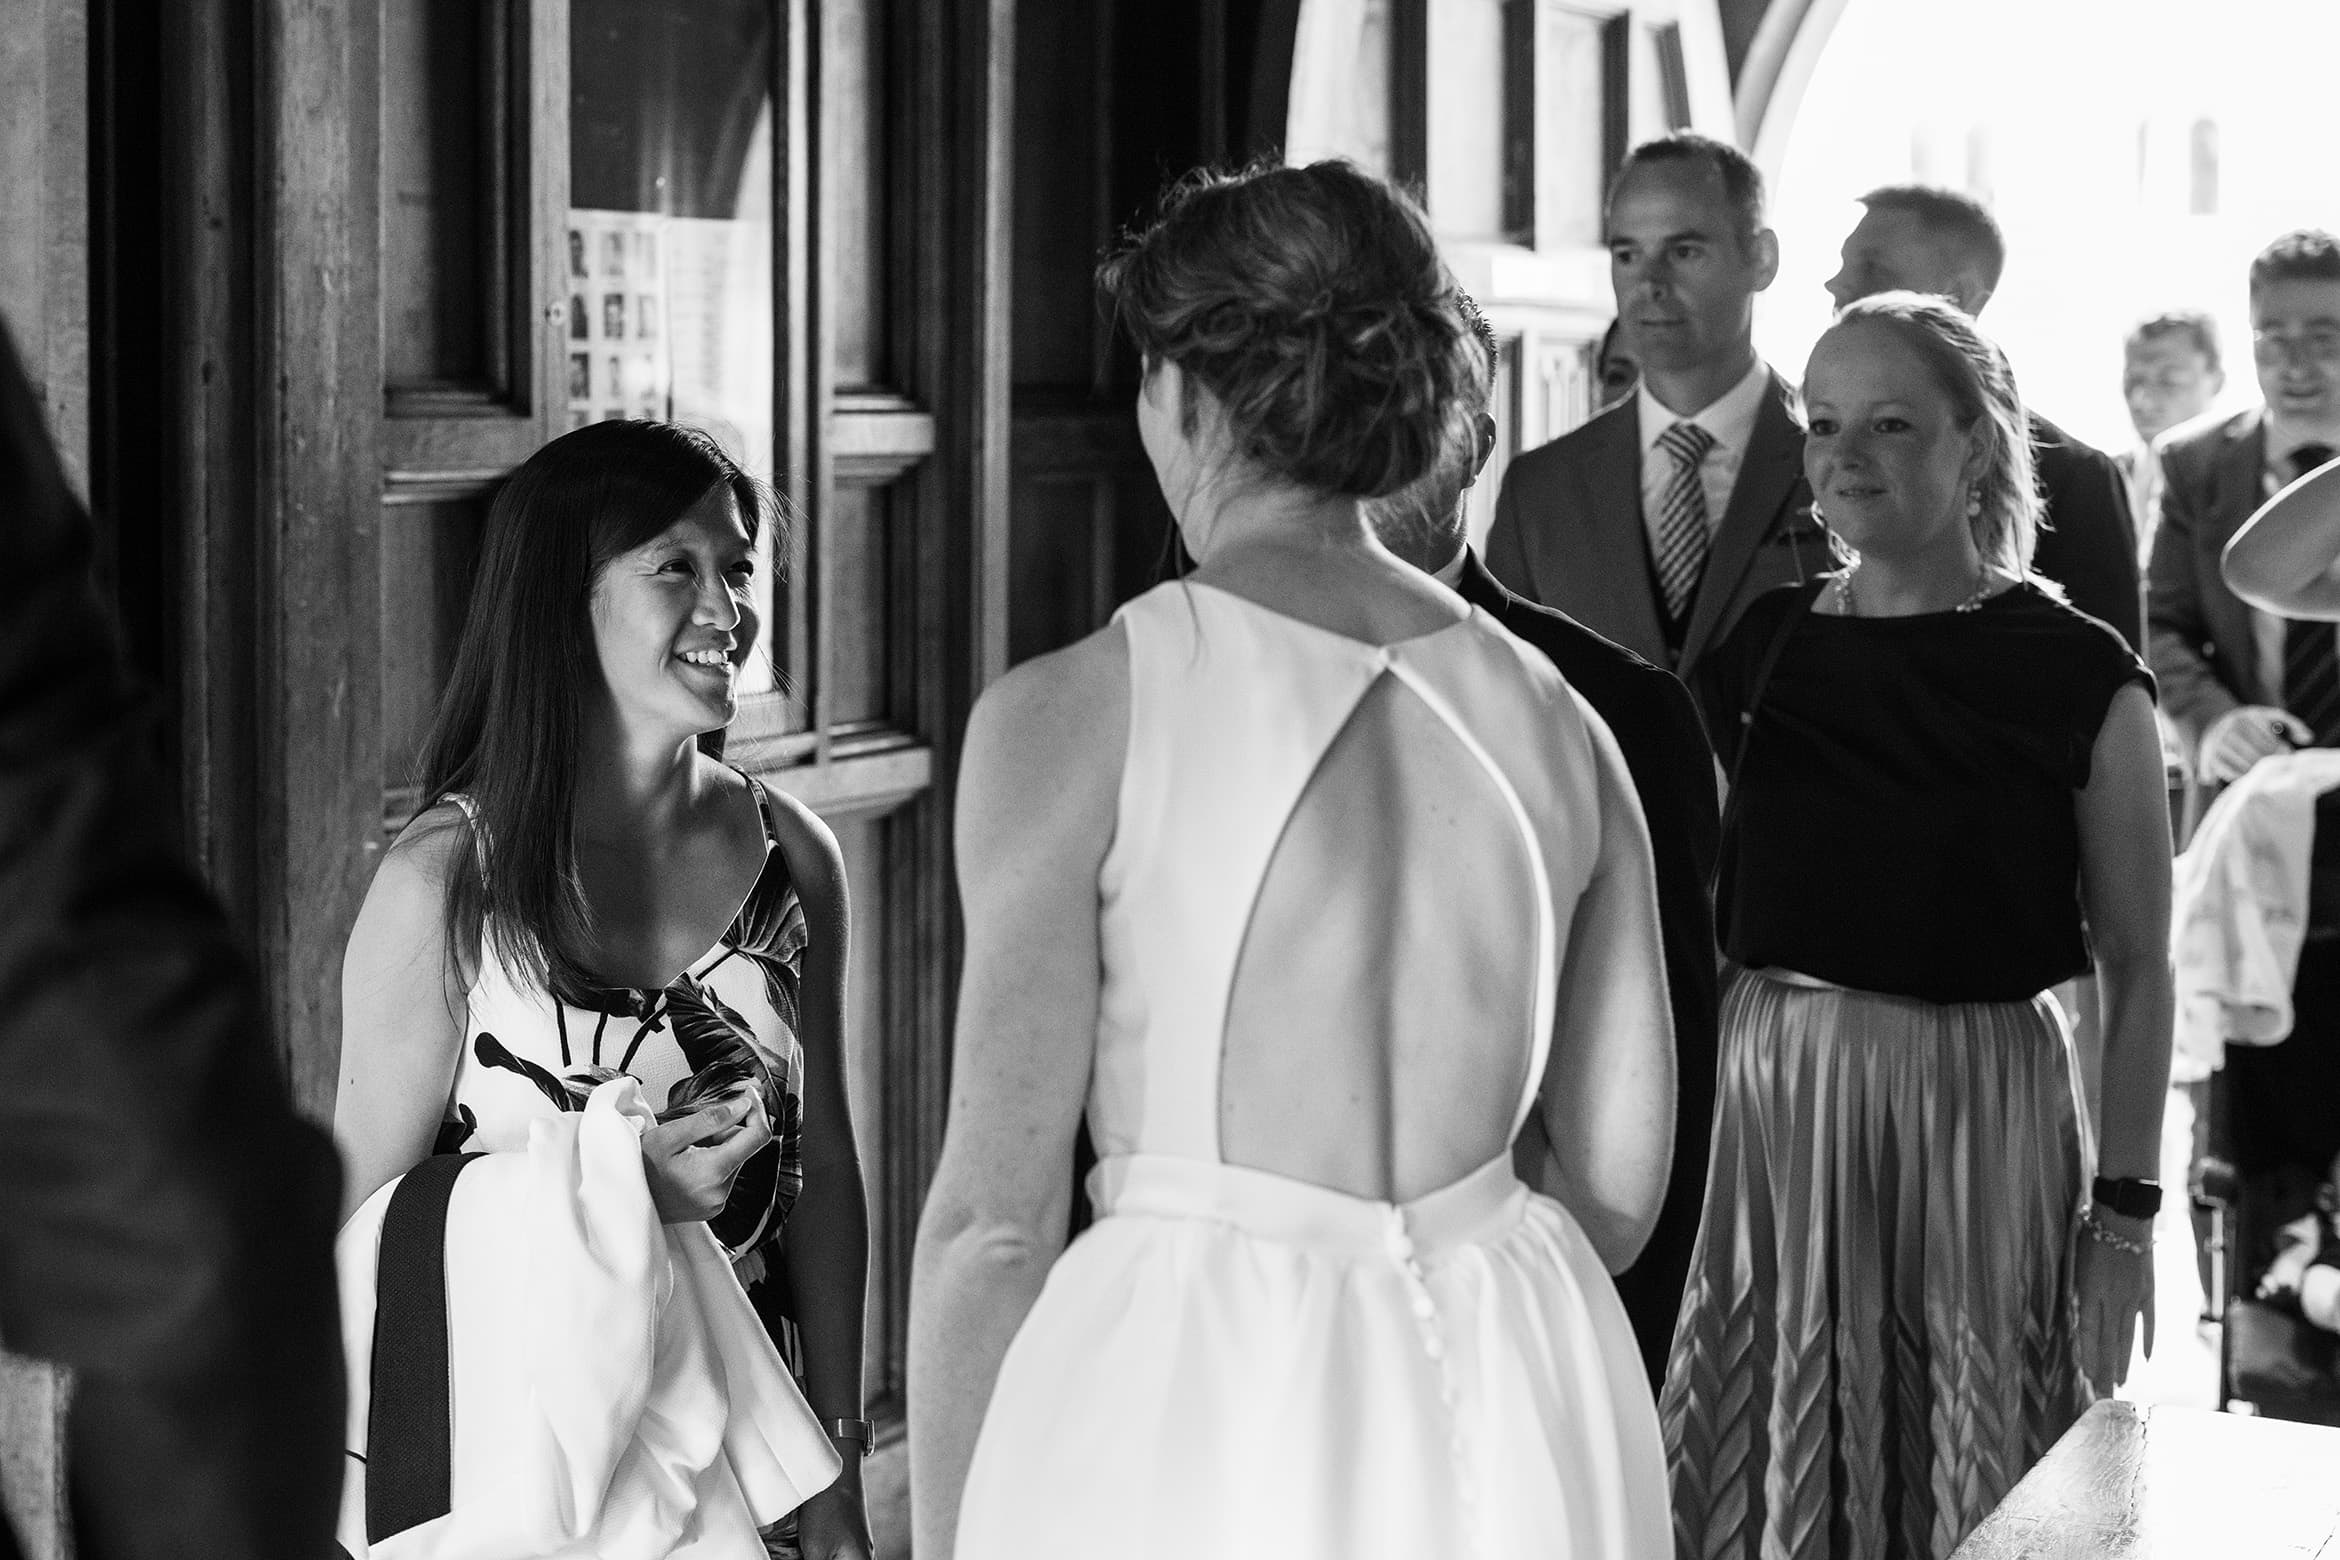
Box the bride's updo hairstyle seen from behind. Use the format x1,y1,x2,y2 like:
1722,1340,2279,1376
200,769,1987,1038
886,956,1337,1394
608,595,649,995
1097,161,1479,498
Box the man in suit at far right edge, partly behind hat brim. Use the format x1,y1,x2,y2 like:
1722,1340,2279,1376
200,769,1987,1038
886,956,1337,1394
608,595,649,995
2148,229,2340,1291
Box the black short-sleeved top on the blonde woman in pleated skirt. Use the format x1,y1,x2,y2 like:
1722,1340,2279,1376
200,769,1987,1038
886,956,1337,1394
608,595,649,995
1701,585,2153,1003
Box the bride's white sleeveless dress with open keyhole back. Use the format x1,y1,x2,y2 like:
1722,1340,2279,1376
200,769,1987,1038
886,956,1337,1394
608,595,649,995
957,582,1671,1560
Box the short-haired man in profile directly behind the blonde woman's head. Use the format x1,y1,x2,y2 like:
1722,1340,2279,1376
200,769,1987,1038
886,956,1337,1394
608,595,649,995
1828,185,2146,653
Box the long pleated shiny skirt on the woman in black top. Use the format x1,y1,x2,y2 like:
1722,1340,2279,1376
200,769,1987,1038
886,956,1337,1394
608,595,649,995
1659,971,2092,1560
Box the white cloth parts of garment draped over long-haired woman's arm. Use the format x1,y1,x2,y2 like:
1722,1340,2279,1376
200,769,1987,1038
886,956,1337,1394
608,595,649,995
337,1078,838,1560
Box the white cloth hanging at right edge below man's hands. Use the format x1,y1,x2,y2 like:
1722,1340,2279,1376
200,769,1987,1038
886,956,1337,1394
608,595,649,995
2169,748,2340,1083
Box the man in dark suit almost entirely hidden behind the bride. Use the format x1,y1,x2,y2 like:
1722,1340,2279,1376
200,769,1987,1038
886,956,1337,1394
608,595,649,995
1367,311,1722,1387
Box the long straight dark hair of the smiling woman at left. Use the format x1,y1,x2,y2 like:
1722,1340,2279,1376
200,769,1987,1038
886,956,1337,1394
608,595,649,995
421,421,777,992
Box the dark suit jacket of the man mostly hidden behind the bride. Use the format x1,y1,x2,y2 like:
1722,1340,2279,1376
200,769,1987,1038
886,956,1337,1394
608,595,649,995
1455,552,1722,1385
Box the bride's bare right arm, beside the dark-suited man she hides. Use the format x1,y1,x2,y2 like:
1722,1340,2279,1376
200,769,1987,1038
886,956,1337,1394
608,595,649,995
1523,711,1673,1272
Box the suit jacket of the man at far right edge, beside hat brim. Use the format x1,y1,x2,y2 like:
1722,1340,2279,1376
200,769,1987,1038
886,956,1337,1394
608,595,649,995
2146,407,2267,758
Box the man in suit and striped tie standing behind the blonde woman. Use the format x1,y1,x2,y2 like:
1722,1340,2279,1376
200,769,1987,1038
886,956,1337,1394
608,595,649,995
1486,133,1832,678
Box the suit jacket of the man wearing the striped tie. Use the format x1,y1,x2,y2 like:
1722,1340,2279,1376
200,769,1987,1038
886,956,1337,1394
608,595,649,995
1486,372,1835,678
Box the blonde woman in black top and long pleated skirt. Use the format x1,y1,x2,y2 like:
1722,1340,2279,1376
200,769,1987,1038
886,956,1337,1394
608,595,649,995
1659,292,2172,1560
